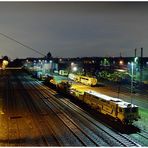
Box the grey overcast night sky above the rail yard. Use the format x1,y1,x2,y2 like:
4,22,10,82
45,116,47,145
0,2,148,59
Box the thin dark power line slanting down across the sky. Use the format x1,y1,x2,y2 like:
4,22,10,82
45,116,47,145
0,32,46,56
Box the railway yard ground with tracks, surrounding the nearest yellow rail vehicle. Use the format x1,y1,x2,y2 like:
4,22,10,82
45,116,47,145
0,70,148,147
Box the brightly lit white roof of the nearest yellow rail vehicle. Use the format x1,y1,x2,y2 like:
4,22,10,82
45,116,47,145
85,90,137,108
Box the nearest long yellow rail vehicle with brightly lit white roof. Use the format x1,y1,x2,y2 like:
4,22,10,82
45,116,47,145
70,88,139,124
